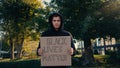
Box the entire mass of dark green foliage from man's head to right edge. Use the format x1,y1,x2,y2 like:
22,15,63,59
49,0,120,39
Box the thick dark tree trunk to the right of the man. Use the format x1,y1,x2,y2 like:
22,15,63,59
82,38,94,65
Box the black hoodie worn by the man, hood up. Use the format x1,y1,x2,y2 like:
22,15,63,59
37,13,75,68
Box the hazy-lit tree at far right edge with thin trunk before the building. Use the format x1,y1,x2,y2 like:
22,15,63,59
94,0,120,51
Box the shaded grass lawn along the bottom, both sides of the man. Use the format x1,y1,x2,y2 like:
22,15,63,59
0,55,120,68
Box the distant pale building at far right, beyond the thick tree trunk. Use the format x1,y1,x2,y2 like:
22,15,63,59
93,37,116,55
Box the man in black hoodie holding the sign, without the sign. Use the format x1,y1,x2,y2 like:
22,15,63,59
37,13,75,68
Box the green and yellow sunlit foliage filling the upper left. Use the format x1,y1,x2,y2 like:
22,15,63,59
0,0,45,38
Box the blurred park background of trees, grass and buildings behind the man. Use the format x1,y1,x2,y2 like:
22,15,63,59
0,0,120,68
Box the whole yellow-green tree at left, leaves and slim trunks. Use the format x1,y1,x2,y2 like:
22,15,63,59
0,0,42,59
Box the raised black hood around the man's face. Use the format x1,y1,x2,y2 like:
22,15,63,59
49,13,63,31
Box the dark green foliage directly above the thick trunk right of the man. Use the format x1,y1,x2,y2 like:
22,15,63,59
48,0,101,39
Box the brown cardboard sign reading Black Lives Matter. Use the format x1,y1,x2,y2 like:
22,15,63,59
40,36,71,66
